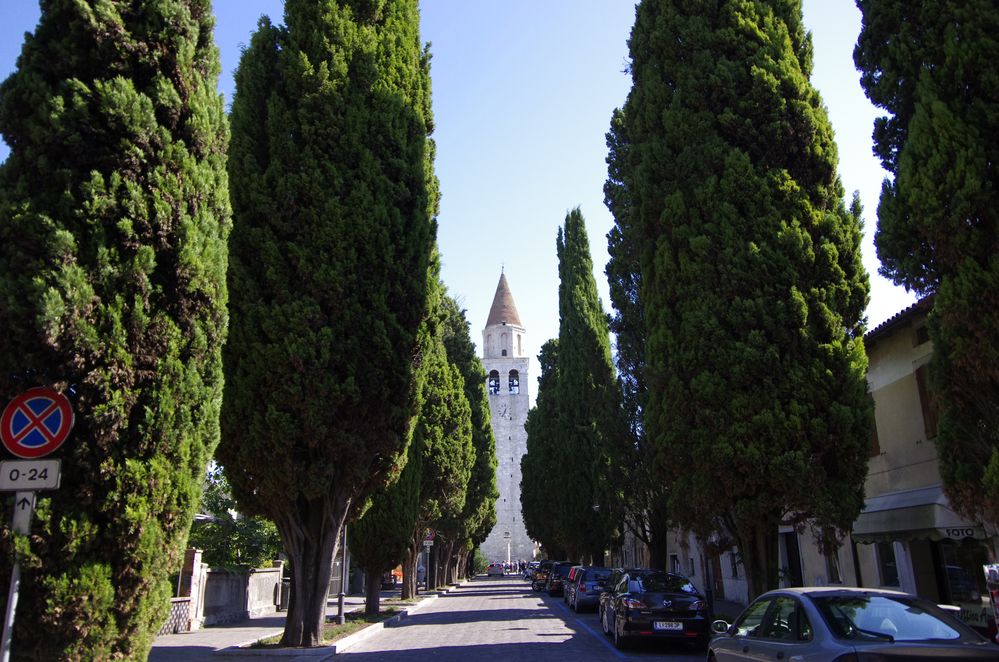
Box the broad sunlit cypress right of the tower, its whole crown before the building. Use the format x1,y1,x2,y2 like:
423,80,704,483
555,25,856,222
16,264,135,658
624,0,871,597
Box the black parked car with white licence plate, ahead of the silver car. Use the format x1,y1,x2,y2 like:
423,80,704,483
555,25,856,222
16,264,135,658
600,569,710,648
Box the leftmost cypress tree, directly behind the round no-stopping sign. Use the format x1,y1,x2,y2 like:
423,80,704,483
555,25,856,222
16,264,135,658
0,0,230,660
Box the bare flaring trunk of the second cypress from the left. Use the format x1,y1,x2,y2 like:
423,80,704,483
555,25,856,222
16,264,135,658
275,498,350,648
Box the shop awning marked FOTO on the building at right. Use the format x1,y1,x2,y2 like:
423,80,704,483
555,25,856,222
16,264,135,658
853,485,989,543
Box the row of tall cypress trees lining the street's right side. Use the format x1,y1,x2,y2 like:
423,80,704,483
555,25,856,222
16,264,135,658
523,0,999,596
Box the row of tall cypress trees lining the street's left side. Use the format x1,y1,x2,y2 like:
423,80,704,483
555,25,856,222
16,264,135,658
0,0,495,660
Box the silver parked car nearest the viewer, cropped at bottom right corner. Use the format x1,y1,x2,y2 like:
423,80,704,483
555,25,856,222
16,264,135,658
708,586,999,662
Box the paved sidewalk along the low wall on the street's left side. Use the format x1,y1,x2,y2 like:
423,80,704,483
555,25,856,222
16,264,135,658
149,589,432,662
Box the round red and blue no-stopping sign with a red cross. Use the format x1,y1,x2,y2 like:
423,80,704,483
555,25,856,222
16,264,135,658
0,387,74,460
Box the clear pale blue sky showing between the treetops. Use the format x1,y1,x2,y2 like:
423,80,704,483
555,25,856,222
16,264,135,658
0,0,915,401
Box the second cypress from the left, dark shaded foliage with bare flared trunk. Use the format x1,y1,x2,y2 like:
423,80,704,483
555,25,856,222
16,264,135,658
219,0,437,646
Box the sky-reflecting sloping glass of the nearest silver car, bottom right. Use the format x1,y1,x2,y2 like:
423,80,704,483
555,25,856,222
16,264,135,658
813,595,961,641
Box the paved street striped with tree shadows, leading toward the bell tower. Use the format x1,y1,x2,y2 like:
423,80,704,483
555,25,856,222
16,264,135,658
337,577,704,662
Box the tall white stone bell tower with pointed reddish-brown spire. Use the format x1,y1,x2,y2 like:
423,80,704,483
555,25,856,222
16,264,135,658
481,271,534,563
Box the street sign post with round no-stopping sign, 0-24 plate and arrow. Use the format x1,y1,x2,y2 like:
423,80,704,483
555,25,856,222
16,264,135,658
0,388,74,662
